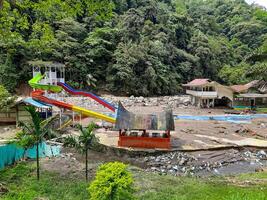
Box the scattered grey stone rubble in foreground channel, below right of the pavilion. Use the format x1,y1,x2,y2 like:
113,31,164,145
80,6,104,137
140,149,267,176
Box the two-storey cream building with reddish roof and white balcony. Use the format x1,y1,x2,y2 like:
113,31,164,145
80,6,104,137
183,79,234,108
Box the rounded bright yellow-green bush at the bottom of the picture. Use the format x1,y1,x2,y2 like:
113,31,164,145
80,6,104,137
88,162,134,200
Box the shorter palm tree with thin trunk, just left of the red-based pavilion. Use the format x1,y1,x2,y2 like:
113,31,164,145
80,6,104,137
64,123,97,181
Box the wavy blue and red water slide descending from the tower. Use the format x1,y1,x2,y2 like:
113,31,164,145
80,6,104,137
57,82,116,112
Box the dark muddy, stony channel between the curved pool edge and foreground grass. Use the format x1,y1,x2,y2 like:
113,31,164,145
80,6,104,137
41,148,267,178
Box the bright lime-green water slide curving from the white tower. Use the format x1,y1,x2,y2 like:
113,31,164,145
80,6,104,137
29,73,62,92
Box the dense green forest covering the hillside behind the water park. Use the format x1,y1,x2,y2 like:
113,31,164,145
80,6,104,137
0,0,267,96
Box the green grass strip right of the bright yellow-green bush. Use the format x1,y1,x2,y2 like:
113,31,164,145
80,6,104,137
135,167,267,200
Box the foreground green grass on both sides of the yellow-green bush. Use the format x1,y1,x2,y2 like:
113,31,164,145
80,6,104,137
0,162,267,200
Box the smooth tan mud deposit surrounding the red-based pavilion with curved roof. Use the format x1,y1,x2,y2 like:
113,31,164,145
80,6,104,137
90,102,267,150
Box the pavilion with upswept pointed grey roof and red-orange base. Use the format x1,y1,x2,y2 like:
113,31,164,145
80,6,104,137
115,102,174,149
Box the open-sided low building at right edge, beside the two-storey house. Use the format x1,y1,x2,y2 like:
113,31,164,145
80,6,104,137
231,80,267,112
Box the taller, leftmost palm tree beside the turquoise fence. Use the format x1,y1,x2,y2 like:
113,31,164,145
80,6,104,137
16,106,52,180
